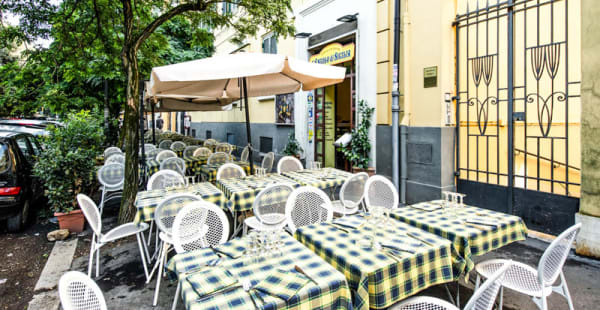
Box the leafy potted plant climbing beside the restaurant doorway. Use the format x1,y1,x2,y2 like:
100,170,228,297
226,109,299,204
338,100,375,176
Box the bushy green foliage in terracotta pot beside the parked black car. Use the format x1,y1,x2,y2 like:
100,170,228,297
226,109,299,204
34,111,104,212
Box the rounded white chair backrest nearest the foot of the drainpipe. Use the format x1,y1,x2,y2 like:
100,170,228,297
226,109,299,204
365,175,399,210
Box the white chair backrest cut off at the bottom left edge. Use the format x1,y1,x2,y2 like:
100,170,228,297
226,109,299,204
58,271,107,310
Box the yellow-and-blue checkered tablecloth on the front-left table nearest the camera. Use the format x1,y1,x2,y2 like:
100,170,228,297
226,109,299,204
166,233,352,310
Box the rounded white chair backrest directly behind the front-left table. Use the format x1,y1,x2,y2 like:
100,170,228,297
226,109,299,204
172,201,230,253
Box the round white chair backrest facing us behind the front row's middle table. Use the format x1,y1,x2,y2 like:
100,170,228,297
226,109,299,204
285,186,333,231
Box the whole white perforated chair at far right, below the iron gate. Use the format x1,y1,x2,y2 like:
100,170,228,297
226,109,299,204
475,223,581,310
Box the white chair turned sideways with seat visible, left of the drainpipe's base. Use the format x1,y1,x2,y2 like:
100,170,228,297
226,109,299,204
332,172,369,216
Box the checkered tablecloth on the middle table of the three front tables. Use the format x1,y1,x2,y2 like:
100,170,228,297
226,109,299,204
294,215,463,309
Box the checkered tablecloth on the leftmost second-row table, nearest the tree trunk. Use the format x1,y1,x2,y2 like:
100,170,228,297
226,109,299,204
133,182,229,223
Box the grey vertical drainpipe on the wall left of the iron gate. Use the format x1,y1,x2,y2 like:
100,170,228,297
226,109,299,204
392,0,400,188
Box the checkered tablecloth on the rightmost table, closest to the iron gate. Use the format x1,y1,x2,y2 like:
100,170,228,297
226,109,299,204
391,200,527,274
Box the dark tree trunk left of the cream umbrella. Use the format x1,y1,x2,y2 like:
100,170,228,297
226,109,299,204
119,48,140,223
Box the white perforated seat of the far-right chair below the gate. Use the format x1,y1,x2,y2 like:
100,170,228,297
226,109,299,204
475,259,552,297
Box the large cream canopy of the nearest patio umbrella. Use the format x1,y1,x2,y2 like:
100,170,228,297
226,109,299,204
148,53,346,98
